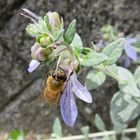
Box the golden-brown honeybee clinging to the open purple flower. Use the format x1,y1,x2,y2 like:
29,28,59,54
44,68,67,104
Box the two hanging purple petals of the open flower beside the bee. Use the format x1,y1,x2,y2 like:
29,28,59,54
60,72,92,127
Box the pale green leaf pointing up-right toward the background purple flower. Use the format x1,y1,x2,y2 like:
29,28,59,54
102,38,124,65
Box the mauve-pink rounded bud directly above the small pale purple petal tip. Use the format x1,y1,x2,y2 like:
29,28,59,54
31,44,52,61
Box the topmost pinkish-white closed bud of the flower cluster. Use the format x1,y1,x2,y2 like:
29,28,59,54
47,12,61,28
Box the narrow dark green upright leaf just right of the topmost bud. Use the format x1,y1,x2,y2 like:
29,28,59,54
64,20,76,44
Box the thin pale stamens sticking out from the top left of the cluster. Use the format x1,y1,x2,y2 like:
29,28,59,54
20,8,39,22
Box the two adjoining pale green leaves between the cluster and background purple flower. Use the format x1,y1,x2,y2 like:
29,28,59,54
82,38,124,67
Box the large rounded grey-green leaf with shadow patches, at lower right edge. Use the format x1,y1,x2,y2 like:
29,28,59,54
110,92,140,125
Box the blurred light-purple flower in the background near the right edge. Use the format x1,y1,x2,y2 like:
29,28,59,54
124,38,138,61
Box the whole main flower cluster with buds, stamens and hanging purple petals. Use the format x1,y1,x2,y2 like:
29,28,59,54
22,9,92,127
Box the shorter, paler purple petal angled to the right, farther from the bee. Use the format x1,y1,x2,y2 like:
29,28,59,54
70,72,92,103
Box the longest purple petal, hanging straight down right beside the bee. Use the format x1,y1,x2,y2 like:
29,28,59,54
60,81,78,127
